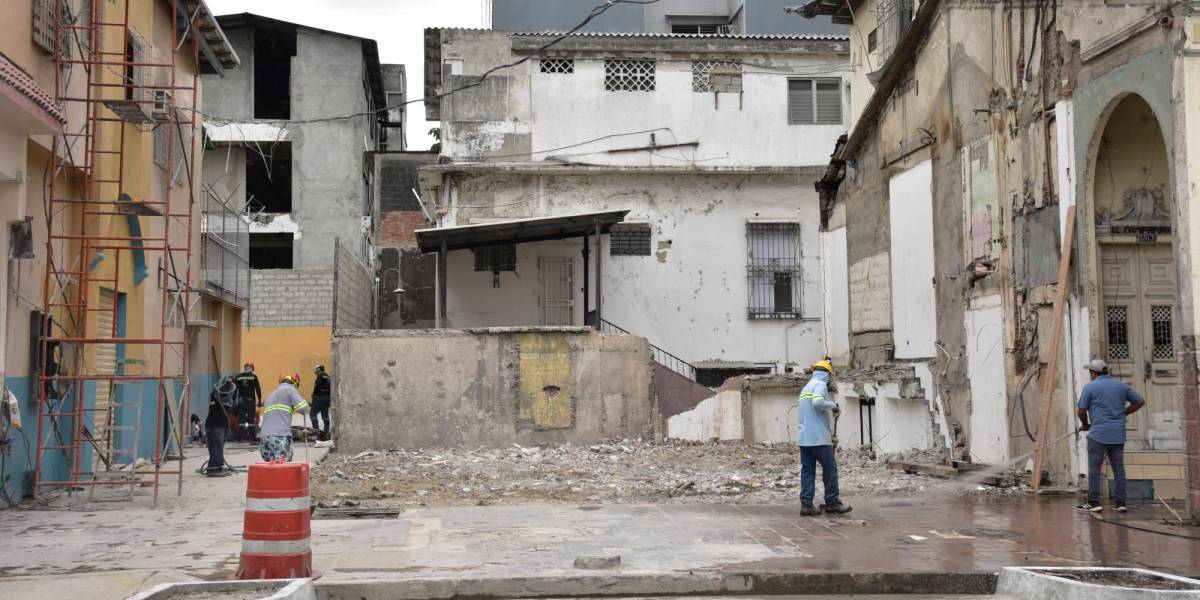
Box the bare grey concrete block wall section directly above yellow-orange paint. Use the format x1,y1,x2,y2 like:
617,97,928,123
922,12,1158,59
242,269,334,328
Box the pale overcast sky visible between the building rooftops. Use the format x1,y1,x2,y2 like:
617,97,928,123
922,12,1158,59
208,0,485,150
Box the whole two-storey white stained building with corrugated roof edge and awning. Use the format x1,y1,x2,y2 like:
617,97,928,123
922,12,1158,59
418,29,850,383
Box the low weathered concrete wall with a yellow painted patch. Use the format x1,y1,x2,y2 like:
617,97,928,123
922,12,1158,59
334,328,658,452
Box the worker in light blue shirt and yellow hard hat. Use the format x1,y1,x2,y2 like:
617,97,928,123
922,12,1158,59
796,359,851,516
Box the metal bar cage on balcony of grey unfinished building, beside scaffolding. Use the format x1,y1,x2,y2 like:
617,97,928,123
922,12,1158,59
200,190,250,304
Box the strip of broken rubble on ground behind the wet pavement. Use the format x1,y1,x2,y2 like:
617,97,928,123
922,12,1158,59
313,440,1027,508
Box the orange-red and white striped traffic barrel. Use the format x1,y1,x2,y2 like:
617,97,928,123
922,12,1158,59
238,462,312,580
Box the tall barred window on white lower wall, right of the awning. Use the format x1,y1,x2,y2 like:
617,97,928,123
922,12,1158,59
746,223,802,319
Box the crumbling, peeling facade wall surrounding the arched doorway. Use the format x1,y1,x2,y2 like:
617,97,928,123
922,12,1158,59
830,1,1188,482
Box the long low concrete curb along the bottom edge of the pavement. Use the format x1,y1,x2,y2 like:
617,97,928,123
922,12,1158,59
317,572,997,600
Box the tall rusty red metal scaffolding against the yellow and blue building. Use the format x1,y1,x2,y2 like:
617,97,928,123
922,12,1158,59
35,0,200,500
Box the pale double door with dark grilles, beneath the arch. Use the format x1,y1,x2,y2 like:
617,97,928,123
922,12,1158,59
1100,244,1183,451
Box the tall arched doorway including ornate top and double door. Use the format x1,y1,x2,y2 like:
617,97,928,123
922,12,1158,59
1091,94,1183,451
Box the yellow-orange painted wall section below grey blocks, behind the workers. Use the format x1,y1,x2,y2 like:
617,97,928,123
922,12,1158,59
241,326,336,397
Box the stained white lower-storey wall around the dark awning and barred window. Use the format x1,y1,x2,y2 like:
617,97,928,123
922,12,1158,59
445,173,826,371
